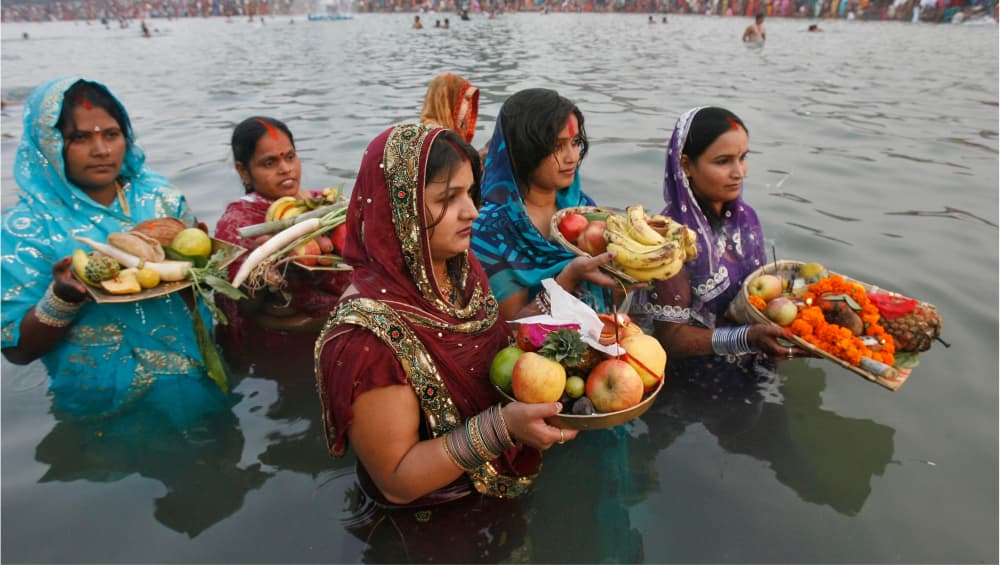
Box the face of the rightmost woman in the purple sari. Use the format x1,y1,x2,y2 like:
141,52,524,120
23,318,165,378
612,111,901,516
681,127,750,214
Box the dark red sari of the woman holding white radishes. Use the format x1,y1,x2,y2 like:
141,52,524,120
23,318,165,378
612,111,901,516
215,192,350,371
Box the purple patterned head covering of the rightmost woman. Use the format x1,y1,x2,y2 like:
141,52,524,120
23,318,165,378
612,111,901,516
662,107,766,327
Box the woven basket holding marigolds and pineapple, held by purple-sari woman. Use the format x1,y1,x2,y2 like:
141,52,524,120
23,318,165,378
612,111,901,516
728,260,909,391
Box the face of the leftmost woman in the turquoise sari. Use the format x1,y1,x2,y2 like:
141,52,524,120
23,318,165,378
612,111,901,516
62,104,128,192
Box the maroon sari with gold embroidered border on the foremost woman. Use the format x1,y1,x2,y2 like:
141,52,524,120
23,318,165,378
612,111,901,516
316,124,541,498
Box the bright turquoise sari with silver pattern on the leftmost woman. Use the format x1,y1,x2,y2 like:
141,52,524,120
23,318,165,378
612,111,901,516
2,77,225,425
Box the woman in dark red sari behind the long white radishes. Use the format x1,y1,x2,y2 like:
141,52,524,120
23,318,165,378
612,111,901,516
215,116,350,369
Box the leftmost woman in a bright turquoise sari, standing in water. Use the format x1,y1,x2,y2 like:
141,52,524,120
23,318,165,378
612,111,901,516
0,77,229,427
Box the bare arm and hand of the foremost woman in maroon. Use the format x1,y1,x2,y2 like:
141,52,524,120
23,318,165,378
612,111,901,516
347,385,578,504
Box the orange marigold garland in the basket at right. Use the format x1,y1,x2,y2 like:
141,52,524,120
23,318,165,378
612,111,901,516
788,275,896,367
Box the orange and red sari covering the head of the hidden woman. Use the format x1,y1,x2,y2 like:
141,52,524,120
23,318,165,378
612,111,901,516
420,73,479,143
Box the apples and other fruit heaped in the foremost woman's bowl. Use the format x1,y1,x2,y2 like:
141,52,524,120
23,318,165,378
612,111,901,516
490,314,667,416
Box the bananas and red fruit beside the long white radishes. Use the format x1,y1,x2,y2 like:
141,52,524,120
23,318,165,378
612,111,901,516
253,188,347,267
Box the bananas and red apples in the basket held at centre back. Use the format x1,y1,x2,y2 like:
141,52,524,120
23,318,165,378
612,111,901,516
558,205,698,282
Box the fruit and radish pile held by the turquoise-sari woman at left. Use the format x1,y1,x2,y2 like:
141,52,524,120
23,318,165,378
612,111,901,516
72,218,212,294
